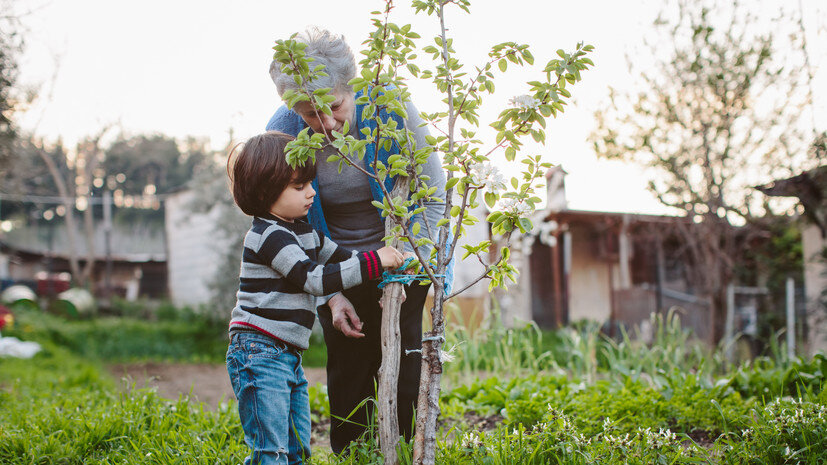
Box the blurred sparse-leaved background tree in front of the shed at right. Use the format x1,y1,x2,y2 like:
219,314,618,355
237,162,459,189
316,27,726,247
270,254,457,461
592,0,814,342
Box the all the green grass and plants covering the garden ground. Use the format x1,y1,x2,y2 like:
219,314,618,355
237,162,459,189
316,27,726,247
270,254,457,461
0,302,827,464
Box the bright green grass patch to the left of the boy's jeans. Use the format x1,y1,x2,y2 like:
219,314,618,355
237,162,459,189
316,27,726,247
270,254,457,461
0,345,246,465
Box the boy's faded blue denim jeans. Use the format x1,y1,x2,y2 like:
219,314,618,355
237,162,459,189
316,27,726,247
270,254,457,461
227,333,310,465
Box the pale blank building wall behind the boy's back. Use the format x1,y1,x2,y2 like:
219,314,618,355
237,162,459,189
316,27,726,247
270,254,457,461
165,191,228,305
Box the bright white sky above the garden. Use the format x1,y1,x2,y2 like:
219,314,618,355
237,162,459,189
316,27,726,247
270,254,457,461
12,0,827,213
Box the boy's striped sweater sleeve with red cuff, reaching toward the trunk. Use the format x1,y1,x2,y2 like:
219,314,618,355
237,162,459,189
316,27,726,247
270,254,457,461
258,229,382,296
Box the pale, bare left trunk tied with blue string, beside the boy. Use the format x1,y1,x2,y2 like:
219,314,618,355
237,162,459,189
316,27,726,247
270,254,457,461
376,177,408,465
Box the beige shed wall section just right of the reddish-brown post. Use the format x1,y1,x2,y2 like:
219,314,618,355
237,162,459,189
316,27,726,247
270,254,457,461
569,224,611,322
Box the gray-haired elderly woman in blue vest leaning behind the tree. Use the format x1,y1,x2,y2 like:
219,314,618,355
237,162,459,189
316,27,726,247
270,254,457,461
267,30,450,454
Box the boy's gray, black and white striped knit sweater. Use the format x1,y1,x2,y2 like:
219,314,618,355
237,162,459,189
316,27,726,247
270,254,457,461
230,216,382,349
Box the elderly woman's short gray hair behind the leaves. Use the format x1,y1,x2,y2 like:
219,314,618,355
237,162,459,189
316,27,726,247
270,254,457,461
270,28,356,95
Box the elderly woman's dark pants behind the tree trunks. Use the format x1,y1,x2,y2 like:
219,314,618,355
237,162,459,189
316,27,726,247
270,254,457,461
319,282,430,454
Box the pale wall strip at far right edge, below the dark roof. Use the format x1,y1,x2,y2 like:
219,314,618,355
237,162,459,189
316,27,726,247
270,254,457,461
802,225,827,354
